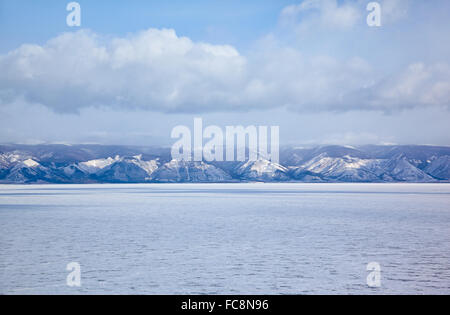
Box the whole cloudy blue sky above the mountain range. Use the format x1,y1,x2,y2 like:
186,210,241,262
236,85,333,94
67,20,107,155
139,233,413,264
0,0,450,145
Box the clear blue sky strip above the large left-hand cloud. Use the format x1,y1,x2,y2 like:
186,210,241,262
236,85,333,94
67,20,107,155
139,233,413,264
0,0,292,51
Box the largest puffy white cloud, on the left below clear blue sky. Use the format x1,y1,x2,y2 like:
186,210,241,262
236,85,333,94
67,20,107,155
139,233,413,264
0,29,245,111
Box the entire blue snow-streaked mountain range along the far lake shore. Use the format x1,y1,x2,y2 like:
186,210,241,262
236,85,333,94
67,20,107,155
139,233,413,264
0,144,450,184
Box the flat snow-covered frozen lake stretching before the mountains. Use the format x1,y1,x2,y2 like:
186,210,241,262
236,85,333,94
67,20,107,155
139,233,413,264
0,184,450,294
